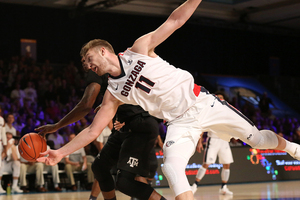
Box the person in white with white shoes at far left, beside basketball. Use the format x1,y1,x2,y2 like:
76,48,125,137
0,132,23,194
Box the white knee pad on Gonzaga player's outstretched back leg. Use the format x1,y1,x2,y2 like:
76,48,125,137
251,130,278,149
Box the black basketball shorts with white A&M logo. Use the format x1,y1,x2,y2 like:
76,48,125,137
101,116,159,177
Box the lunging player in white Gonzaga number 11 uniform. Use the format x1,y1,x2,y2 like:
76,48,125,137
37,0,300,200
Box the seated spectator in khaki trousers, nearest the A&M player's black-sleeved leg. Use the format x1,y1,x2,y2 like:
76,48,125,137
65,133,94,191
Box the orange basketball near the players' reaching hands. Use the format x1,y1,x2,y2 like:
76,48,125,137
18,133,47,162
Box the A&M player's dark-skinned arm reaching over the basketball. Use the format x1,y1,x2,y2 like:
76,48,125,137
35,83,101,136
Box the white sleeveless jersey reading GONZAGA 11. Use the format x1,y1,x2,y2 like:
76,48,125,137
107,49,196,121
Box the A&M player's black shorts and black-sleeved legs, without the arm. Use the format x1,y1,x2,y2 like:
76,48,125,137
93,104,164,200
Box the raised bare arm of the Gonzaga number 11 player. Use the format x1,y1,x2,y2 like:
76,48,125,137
131,0,202,57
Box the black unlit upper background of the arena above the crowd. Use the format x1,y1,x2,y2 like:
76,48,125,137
0,3,300,76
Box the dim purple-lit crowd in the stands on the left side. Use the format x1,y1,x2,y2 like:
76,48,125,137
0,56,101,148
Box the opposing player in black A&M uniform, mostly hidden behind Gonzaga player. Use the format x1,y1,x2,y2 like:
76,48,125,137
36,71,164,200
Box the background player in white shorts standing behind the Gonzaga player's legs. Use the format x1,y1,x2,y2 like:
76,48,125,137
191,92,233,195
